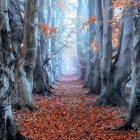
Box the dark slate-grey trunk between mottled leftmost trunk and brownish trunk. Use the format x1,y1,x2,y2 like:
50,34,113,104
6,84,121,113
8,0,23,105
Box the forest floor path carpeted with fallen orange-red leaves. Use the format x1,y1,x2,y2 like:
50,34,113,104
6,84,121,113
14,75,140,140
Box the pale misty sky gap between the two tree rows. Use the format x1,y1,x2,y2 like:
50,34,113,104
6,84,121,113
62,0,77,74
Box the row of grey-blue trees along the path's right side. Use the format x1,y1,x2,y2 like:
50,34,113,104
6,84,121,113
78,0,140,129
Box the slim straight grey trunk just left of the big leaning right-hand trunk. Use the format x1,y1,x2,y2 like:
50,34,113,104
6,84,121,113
101,1,113,94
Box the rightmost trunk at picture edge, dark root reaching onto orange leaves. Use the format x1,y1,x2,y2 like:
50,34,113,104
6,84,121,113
115,14,140,130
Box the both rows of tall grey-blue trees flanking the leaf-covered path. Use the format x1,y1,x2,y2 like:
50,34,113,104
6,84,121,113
0,0,140,140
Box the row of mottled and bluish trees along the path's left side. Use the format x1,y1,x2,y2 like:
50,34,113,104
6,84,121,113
0,0,61,140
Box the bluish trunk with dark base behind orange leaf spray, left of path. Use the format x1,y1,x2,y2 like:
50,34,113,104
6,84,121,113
34,1,54,95
